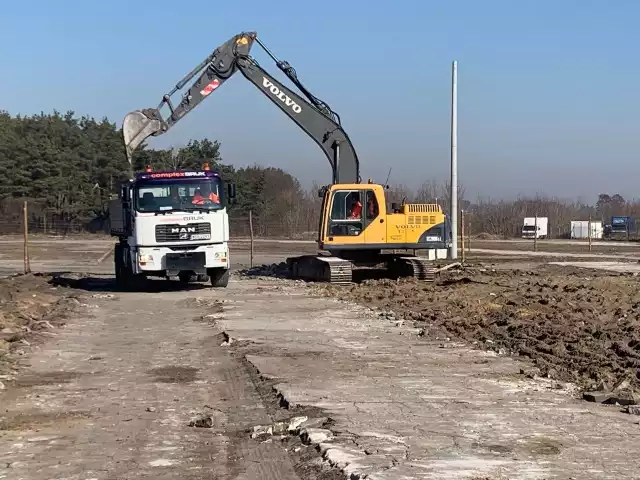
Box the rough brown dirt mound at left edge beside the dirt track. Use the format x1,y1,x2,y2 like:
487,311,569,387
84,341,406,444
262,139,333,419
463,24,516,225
0,275,80,370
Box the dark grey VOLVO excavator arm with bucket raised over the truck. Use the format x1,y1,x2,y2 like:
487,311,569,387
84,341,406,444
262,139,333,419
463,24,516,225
123,32,361,183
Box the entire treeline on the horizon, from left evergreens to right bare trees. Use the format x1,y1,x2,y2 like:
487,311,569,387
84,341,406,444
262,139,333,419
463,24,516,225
0,111,640,238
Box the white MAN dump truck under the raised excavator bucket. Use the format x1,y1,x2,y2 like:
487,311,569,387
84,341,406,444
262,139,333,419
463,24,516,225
109,164,235,289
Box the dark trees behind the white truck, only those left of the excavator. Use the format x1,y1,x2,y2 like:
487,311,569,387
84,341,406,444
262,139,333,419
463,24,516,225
0,112,316,235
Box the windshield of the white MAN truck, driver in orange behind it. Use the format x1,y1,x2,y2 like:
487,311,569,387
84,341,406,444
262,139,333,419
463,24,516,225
134,177,223,212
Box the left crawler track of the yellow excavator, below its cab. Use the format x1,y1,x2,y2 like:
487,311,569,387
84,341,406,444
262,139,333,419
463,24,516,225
287,255,353,285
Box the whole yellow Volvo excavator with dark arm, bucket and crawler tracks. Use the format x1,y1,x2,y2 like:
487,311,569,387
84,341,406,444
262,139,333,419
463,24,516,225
123,32,450,284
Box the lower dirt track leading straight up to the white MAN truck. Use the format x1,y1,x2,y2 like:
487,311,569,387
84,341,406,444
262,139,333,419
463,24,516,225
0,280,336,480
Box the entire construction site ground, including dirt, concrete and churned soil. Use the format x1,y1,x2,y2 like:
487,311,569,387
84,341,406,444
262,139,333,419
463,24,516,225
0,237,640,480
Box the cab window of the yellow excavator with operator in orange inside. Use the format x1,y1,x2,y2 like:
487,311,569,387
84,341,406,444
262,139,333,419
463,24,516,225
327,190,379,236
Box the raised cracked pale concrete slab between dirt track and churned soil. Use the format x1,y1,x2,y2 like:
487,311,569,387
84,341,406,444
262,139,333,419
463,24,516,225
217,279,640,480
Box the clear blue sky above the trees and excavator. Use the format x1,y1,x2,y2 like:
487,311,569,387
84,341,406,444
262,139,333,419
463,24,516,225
0,0,640,200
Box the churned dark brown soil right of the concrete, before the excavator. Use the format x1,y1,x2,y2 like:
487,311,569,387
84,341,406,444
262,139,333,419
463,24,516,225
321,267,640,391
